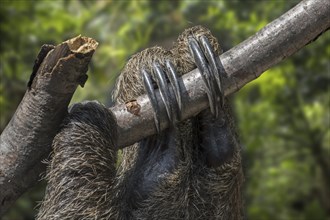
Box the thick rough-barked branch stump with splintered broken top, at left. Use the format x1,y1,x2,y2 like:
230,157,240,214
0,36,97,216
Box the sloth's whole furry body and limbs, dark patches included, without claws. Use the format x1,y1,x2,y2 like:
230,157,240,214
38,26,243,219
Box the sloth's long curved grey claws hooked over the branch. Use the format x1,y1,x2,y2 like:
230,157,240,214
141,36,224,132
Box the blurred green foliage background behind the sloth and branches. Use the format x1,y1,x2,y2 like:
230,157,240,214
0,0,330,220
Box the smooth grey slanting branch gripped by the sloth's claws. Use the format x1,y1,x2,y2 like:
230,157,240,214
111,0,330,148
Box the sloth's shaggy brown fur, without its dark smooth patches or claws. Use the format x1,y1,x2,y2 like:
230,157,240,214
38,26,243,219
